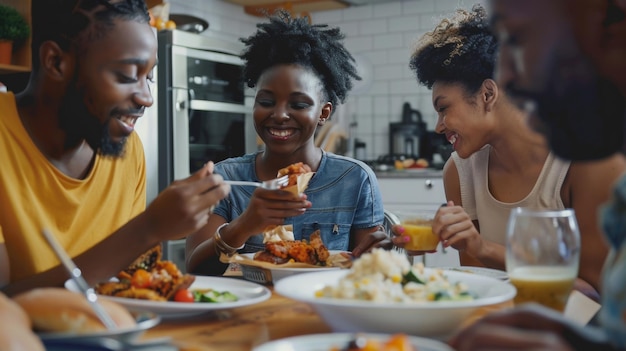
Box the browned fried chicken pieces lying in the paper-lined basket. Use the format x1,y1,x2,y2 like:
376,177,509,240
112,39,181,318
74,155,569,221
254,230,330,266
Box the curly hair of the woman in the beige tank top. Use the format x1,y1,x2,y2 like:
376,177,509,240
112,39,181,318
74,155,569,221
409,5,498,94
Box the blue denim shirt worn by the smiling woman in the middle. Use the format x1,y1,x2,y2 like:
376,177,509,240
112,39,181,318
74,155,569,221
213,152,384,252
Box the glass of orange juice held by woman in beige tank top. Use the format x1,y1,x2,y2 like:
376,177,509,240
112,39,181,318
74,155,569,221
397,210,439,251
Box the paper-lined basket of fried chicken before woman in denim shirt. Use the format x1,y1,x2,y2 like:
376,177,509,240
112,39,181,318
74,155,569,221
228,225,352,284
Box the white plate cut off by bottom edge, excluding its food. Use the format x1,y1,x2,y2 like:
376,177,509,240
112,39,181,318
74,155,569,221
252,333,453,351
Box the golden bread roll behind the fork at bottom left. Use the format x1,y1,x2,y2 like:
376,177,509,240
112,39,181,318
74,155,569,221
13,288,137,334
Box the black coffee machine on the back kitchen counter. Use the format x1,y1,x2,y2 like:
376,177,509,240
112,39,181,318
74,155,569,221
389,102,426,159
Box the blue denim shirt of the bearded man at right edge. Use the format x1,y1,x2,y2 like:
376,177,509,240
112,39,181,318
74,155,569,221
599,176,626,349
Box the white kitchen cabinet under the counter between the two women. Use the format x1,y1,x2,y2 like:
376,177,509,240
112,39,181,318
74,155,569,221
376,175,460,267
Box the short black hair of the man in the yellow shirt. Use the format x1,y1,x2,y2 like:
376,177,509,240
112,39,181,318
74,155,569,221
31,0,150,70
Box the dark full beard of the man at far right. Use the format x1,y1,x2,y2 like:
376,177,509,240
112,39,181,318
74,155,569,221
507,60,626,161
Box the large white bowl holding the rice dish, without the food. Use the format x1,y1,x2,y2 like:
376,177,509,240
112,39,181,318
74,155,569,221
274,268,516,339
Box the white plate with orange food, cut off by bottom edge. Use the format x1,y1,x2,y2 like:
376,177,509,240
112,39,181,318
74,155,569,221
252,333,452,351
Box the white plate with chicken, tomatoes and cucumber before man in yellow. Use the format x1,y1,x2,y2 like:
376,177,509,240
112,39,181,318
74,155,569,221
65,246,271,318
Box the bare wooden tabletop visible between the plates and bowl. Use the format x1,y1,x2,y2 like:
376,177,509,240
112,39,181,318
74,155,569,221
141,278,513,351
